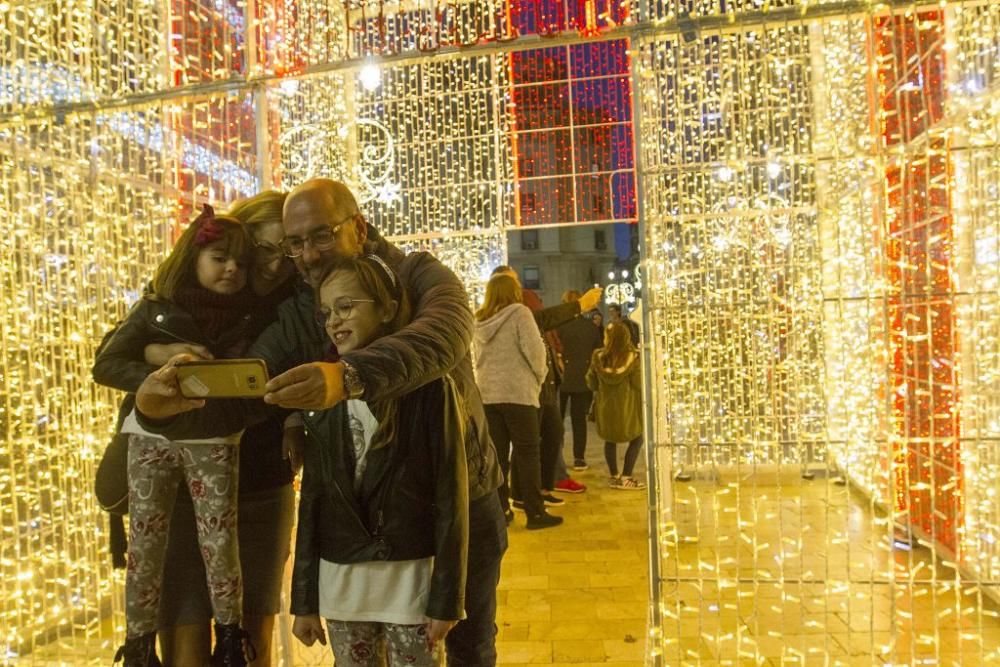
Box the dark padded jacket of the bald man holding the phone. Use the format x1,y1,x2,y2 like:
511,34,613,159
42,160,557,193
140,225,503,500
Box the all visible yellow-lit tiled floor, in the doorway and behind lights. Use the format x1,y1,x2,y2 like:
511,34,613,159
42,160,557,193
37,434,1000,667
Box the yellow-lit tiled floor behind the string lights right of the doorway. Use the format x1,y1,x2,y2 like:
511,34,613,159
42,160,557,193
661,470,1000,667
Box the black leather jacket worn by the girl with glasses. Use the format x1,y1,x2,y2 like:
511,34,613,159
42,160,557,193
291,378,469,620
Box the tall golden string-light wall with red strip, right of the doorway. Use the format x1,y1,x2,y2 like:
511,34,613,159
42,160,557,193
638,3,1000,665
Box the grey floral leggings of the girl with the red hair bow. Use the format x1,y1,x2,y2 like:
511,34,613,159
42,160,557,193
125,435,243,637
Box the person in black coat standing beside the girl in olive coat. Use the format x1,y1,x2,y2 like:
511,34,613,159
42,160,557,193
556,290,601,470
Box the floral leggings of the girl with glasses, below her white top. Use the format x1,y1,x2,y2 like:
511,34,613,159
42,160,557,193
326,619,443,667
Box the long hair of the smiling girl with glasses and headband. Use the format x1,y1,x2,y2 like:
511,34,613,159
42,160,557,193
316,255,412,449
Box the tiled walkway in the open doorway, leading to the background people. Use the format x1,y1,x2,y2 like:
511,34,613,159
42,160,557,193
497,430,649,667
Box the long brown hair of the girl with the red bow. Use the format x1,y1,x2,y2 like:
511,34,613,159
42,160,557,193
153,205,251,301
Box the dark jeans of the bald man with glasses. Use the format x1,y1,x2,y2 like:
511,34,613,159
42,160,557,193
445,493,507,667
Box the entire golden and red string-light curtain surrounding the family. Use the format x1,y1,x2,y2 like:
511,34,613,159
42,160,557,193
0,0,1000,665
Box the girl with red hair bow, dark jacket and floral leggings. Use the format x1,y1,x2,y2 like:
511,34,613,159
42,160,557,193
94,204,255,667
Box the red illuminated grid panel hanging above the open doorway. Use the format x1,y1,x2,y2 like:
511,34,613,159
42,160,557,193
509,39,636,226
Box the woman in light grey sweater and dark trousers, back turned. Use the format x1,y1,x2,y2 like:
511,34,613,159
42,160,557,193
473,274,562,530
